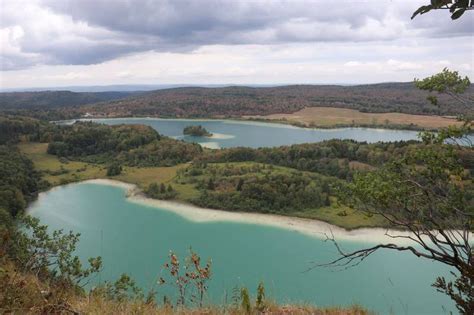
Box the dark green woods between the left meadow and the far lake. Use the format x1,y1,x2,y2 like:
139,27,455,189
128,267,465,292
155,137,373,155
0,115,203,166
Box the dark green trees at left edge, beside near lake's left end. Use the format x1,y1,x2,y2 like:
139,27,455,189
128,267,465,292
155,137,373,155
0,145,45,218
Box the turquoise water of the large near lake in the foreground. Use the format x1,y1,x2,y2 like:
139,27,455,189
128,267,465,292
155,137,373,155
29,183,454,314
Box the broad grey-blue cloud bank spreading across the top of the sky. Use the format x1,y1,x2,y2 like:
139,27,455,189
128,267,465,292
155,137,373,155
2,0,474,70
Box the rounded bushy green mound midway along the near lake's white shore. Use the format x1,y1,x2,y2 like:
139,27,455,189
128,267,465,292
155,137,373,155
179,163,334,214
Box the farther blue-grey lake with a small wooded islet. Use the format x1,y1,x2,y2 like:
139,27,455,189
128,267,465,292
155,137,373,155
82,118,418,149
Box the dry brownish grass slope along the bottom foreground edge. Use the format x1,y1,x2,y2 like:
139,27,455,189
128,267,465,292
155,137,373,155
0,259,374,315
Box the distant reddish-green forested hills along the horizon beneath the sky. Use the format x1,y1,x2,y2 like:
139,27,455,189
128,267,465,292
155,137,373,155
0,83,474,120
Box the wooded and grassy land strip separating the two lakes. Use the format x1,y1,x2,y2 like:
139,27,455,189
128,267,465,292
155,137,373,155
0,116,474,228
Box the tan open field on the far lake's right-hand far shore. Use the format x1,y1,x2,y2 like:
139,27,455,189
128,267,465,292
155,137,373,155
244,107,461,129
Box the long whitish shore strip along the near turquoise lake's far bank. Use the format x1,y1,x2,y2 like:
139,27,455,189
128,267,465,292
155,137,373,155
79,179,410,244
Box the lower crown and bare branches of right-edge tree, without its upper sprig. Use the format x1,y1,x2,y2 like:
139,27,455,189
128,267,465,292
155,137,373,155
336,145,474,314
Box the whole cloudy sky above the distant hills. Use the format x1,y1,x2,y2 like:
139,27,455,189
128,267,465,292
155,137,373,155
0,0,474,89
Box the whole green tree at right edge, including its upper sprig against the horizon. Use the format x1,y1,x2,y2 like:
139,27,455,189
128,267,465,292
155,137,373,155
320,69,474,314
